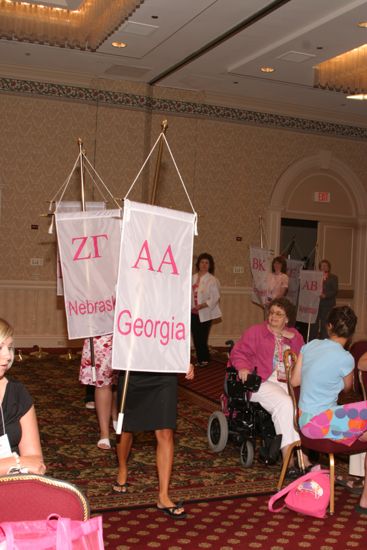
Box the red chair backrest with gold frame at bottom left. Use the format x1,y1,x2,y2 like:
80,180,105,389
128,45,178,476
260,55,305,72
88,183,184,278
0,474,90,521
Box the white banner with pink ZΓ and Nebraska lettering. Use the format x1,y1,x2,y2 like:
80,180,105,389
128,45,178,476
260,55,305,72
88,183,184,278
55,209,121,339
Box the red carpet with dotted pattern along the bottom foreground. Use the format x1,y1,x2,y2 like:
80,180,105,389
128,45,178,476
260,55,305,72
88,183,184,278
103,487,367,550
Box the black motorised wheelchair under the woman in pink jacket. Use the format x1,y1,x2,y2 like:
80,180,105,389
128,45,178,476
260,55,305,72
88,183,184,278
207,340,282,468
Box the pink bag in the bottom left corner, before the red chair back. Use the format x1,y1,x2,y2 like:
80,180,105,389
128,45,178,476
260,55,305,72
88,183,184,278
0,514,104,550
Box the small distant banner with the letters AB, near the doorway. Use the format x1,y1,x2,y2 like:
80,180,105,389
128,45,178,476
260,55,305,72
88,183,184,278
297,269,323,323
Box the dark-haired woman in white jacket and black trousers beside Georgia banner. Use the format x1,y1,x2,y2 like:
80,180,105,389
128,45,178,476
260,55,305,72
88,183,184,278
191,252,222,367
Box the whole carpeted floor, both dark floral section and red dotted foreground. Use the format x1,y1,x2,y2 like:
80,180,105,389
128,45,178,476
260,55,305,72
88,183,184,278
12,355,367,550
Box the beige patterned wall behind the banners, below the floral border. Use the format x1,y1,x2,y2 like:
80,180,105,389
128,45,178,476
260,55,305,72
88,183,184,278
0,79,367,345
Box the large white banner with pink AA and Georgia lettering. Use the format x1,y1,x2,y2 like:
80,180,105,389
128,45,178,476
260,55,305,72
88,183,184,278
112,199,195,373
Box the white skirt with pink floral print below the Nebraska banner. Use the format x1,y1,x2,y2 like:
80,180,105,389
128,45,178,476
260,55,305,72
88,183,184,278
79,334,118,387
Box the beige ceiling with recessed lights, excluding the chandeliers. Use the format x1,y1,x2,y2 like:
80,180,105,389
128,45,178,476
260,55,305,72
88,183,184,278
0,0,367,126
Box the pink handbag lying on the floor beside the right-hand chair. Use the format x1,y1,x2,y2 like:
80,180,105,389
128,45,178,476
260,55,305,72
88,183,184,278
268,470,330,518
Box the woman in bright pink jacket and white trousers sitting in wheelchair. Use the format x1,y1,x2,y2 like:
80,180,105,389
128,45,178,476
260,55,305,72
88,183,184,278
230,298,310,477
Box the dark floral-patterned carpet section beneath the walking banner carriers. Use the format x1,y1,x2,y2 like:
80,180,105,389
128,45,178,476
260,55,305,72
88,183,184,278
12,356,292,512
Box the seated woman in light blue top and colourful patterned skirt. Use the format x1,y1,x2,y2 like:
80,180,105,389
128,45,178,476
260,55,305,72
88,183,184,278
291,306,367,514
